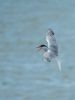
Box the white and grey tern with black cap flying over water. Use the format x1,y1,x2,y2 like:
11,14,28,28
37,28,61,71
